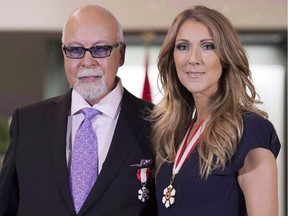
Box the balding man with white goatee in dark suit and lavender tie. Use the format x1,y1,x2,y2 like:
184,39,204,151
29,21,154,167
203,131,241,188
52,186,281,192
0,5,156,216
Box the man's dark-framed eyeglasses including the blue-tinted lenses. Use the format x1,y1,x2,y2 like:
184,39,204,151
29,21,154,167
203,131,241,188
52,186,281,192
63,42,123,59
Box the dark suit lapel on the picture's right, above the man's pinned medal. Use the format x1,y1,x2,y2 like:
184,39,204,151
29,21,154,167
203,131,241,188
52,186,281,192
79,91,142,215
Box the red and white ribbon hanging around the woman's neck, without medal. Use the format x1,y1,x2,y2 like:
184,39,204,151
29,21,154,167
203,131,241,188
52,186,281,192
172,119,208,176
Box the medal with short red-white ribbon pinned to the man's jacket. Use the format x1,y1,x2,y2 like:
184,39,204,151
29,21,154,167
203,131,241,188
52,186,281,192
137,167,150,202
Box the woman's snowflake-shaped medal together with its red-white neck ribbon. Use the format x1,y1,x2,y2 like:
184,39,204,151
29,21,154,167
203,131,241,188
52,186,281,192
162,119,208,208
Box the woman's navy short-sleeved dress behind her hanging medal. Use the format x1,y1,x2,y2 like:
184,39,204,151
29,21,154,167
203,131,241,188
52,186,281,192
156,113,280,216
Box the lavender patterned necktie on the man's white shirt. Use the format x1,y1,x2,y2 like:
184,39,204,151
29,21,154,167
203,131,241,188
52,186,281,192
70,108,100,214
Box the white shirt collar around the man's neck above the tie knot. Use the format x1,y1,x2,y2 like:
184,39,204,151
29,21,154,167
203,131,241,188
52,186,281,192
71,77,124,118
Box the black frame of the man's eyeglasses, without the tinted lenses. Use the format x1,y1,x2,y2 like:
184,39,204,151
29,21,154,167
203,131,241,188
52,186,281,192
62,41,125,59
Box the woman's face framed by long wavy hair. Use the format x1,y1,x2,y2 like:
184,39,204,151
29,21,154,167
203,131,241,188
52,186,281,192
174,20,222,98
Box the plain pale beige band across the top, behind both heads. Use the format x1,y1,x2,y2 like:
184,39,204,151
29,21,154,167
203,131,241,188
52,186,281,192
0,0,287,31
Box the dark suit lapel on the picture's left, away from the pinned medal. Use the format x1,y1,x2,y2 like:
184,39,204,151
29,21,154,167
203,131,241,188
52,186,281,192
47,91,74,215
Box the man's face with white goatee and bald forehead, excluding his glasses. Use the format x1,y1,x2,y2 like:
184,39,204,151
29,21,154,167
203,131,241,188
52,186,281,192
63,11,125,104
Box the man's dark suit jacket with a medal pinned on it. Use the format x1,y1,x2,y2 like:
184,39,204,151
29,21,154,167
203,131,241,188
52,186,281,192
0,90,156,216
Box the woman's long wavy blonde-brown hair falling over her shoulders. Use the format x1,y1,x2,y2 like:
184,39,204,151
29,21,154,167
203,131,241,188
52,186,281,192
151,6,267,178
